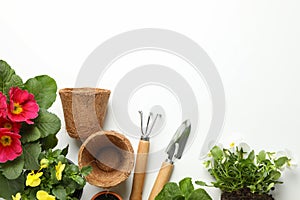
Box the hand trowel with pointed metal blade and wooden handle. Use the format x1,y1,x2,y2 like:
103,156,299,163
148,120,191,200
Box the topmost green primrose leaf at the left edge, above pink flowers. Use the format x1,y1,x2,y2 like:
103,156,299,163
0,60,23,96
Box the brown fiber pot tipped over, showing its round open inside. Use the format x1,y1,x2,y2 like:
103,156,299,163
78,131,134,188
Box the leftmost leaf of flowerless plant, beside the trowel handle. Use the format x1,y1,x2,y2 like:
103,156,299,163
155,182,184,200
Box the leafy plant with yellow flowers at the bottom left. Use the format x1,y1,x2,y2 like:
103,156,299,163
12,147,91,200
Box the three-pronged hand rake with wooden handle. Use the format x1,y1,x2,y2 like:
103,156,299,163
130,111,161,200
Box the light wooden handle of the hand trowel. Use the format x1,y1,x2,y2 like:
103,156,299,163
148,162,174,200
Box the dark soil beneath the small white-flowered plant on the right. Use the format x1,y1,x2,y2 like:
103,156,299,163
221,188,274,200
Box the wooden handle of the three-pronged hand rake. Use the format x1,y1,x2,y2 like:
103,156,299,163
130,140,150,200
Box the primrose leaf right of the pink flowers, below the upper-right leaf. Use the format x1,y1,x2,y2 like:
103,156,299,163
21,109,61,143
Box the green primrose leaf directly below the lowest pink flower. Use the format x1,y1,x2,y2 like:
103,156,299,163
2,154,24,180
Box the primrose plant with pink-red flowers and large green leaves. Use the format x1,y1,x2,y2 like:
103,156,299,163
0,60,61,199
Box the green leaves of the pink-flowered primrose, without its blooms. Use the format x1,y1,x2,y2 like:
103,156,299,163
0,60,61,197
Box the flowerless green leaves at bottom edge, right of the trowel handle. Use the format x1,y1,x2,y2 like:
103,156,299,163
155,178,212,200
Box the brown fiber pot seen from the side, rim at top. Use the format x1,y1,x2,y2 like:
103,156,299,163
59,88,110,140
